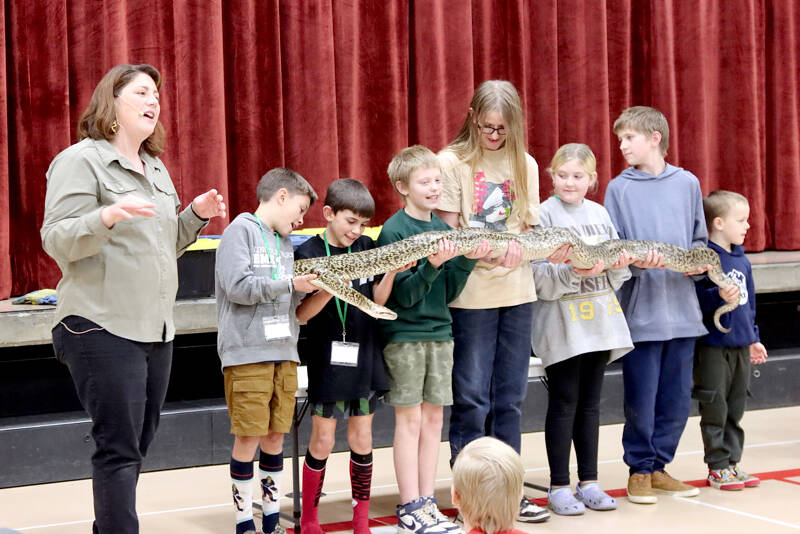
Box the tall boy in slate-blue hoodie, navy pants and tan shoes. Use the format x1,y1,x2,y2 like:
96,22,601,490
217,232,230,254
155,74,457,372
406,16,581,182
605,106,733,504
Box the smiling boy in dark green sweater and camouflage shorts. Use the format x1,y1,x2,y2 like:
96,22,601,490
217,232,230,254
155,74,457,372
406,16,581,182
378,145,489,534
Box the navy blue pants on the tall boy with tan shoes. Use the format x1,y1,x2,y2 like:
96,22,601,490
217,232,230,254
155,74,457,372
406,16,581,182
622,337,696,474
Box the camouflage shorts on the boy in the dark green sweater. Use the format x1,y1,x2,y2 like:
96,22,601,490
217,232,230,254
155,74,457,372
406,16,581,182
383,341,453,406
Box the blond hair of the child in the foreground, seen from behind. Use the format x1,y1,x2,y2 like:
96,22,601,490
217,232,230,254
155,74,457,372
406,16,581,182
453,437,524,534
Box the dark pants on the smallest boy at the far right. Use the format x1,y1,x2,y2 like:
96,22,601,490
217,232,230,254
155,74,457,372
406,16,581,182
692,344,750,469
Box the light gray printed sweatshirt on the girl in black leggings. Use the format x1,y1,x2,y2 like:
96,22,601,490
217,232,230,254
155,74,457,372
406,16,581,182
531,197,633,367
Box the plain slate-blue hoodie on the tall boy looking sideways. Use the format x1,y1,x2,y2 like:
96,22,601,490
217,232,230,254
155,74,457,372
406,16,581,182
605,163,708,343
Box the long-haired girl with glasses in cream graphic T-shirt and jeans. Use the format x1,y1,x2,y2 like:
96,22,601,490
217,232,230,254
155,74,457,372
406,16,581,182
437,80,558,522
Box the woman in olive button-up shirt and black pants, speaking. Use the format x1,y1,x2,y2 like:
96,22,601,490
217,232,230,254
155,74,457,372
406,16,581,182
41,65,225,534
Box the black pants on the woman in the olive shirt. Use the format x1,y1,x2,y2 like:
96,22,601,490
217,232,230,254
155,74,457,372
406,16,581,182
53,316,172,534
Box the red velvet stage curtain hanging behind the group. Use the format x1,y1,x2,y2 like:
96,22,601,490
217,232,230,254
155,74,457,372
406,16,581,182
0,0,800,298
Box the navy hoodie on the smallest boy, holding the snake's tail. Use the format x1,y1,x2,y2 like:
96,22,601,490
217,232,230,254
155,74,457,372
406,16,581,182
695,241,759,347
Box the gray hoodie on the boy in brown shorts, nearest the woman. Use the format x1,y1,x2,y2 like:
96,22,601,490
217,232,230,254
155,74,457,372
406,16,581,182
214,213,303,368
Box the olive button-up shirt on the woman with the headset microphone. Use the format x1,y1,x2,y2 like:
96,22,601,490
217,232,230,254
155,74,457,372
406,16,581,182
41,139,207,342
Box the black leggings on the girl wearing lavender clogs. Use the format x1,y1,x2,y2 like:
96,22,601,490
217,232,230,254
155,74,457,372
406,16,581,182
544,351,609,486
